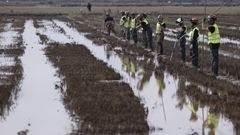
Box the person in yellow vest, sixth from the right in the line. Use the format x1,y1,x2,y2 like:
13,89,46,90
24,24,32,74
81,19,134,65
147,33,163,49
130,13,138,44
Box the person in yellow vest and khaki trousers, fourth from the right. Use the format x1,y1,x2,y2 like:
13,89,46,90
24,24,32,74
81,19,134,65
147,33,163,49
156,15,166,55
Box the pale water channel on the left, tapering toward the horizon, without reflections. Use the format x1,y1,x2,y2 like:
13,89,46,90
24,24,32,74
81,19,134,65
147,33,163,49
0,21,73,135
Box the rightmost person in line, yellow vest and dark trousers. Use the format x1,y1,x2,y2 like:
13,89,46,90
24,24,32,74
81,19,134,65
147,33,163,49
203,15,221,76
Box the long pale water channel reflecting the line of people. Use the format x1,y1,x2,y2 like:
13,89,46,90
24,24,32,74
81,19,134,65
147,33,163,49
38,20,234,135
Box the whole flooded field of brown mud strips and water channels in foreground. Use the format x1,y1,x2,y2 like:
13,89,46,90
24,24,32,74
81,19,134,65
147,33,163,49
0,16,240,135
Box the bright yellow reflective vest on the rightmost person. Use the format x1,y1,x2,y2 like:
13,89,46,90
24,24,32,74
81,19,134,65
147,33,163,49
208,24,221,44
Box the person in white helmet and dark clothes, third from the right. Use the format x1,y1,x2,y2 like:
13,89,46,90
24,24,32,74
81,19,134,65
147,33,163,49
176,18,187,63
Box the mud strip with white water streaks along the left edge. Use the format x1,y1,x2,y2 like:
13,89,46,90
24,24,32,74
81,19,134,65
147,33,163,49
0,19,24,120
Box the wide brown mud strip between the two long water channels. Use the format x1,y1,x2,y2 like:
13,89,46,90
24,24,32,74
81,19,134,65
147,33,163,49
45,43,148,134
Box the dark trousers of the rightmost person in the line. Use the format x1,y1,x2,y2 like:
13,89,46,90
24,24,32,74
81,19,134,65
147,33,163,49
210,44,220,75
